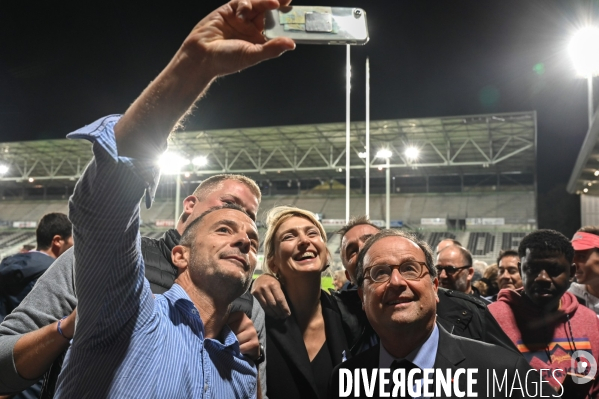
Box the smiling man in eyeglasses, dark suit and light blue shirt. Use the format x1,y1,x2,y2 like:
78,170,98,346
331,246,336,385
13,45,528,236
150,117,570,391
330,230,538,398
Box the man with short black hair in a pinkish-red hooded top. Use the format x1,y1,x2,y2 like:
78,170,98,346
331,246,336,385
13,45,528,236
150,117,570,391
489,230,599,398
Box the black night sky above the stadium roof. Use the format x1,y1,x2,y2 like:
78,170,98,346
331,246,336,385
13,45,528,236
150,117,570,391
0,0,599,234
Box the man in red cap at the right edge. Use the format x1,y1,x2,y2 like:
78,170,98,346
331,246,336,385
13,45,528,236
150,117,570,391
568,226,599,314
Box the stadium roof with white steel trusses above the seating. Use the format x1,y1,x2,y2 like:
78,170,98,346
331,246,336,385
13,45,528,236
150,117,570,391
0,112,537,184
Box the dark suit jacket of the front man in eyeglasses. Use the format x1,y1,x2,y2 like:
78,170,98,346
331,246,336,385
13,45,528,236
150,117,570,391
329,326,553,398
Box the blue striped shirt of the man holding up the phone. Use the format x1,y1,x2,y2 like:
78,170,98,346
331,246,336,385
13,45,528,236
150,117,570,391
56,116,257,399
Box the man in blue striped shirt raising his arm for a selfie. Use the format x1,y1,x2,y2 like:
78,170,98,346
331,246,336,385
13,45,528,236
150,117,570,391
56,0,295,398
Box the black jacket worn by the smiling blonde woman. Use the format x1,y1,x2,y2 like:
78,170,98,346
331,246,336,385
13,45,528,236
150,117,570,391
266,291,351,399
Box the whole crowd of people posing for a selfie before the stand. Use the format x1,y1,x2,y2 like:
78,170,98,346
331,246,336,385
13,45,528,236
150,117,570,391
0,0,599,399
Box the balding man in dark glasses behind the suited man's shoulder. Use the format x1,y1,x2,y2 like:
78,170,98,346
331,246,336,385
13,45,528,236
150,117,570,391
435,245,489,303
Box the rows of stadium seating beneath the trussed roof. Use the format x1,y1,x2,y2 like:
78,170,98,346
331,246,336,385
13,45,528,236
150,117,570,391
0,191,536,265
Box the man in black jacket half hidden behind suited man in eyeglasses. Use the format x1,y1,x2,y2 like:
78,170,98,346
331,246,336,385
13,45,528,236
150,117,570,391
252,216,520,355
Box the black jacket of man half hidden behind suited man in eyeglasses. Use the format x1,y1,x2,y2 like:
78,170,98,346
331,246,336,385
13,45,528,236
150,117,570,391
333,288,520,355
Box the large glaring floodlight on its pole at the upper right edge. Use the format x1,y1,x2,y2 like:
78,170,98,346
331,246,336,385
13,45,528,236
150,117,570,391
569,26,599,128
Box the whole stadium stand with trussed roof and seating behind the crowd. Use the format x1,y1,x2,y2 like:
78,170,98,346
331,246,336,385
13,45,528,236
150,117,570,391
0,112,537,264
